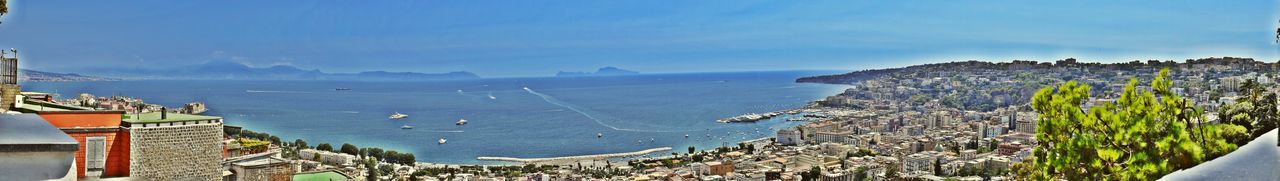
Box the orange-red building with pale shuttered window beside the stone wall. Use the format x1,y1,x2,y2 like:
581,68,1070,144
36,110,129,178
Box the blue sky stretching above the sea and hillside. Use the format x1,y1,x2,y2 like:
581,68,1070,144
0,0,1280,77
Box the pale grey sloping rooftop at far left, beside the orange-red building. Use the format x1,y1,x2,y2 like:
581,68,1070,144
0,114,79,151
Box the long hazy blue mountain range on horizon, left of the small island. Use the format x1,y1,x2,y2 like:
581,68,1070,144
85,62,480,81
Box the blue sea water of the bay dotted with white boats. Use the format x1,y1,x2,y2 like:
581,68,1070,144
23,72,845,164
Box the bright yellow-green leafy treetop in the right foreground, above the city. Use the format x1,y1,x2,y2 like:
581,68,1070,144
1015,69,1243,180
